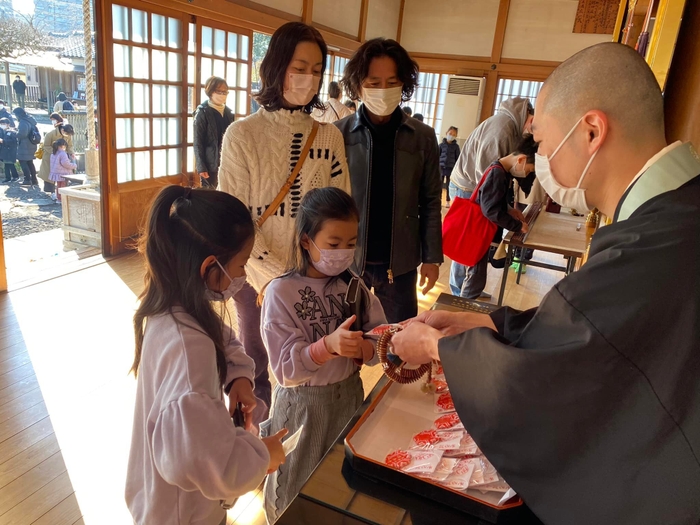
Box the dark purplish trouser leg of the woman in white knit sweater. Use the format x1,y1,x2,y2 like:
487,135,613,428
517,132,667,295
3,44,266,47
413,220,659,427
233,283,272,424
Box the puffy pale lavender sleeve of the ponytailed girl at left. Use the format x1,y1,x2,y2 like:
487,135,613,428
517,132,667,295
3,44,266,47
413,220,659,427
151,392,270,500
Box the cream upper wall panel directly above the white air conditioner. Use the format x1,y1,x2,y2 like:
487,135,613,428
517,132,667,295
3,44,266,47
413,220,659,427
401,0,499,56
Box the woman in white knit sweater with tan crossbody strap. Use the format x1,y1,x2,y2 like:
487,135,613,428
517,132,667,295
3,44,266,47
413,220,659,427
219,22,350,422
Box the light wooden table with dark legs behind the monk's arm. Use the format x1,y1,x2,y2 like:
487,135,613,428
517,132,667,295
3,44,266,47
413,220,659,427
498,208,586,306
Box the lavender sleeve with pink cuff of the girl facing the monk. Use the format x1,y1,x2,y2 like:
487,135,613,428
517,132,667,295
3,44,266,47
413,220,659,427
261,281,340,387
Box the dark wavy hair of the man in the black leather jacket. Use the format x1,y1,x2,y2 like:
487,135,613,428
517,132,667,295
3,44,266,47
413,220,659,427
340,38,418,102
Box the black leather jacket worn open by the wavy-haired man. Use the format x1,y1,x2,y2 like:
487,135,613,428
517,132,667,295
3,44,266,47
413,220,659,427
335,109,443,276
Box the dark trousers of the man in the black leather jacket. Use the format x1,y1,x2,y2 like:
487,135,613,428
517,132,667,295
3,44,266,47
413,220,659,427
362,263,418,323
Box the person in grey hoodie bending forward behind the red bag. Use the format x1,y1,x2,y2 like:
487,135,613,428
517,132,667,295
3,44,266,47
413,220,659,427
449,97,535,299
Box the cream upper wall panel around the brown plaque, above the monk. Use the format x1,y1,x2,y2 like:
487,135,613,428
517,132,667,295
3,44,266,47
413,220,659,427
503,0,612,61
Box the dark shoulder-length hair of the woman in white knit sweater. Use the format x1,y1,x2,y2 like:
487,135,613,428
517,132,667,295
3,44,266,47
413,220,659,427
255,22,328,113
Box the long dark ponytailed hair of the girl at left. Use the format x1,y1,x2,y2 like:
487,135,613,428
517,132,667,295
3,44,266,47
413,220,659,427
131,186,255,386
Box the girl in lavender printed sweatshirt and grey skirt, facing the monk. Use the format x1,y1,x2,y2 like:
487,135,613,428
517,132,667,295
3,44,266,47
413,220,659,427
260,188,386,523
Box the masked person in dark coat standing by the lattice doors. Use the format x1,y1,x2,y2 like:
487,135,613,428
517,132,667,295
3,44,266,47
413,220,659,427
194,77,234,188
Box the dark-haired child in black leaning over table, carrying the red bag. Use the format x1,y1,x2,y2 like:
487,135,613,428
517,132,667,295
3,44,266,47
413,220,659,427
452,135,537,300
